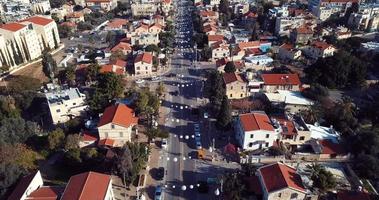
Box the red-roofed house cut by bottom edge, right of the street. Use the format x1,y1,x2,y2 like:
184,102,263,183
257,163,307,200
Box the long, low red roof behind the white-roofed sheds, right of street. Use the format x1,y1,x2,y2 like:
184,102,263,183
261,74,301,85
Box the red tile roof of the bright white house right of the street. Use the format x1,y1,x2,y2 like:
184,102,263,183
239,112,274,131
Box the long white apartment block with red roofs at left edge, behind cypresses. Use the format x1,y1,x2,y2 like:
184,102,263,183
0,16,60,70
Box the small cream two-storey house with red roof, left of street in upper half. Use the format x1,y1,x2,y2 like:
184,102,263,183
134,52,153,76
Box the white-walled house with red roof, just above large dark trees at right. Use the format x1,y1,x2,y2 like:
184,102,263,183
304,41,337,59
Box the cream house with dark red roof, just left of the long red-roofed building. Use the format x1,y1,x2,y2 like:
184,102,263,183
223,73,248,99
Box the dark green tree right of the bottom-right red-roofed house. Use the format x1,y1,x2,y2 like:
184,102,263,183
307,164,337,192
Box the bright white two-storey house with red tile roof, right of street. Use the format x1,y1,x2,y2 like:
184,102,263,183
234,112,279,150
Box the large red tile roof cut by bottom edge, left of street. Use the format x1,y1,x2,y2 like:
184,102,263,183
61,172,111,200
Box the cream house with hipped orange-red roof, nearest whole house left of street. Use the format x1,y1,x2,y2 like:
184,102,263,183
97,104,138,147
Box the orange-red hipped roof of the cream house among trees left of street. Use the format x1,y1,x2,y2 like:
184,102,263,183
97,103,138,128
